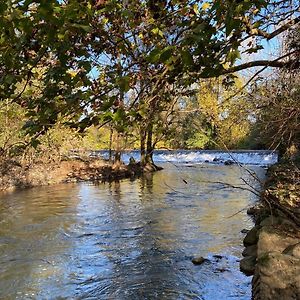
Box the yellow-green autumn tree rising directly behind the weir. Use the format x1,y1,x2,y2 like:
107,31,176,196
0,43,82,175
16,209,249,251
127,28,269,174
165,77,254,149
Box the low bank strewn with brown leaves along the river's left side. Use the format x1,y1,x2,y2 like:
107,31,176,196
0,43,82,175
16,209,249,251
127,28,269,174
0,158,154,192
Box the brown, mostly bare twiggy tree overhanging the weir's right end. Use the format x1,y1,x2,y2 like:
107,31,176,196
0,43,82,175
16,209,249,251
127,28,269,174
246,72,300,157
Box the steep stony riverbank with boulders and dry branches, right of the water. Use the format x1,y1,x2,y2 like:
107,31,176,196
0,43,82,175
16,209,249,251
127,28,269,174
240,163,300,300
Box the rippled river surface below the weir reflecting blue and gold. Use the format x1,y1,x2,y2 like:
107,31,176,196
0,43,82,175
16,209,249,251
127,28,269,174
0,165,263,299
